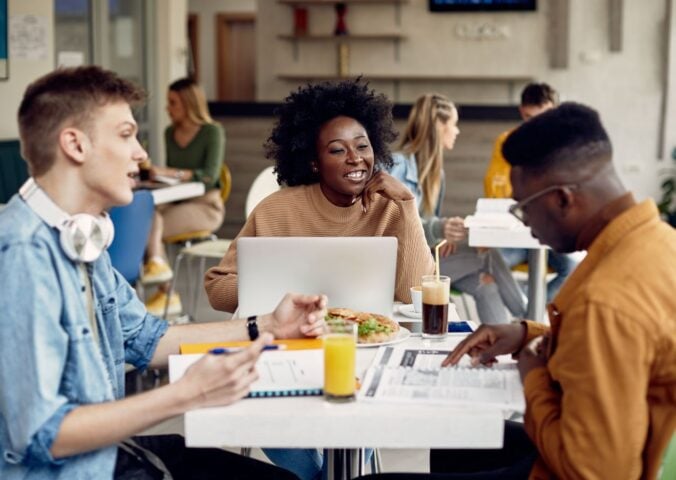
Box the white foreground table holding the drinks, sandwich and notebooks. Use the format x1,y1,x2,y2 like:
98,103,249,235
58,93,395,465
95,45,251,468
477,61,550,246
169,336,504,478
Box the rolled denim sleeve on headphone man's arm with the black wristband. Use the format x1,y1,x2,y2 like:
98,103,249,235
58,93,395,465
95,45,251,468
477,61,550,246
106,262,169,370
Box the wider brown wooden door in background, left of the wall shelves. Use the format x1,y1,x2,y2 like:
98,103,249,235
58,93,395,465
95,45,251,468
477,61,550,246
215,13,256,102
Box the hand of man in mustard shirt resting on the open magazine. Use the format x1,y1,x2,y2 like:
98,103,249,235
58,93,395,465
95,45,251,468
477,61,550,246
441,323,526,367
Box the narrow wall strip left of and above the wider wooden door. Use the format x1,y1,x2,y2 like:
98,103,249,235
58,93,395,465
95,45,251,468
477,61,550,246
188,0,257,100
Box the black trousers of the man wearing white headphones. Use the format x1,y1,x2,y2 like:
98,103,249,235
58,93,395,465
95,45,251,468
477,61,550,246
113,435,298,480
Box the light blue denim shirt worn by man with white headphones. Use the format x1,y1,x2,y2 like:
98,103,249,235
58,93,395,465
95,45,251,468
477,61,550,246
0,195,167,480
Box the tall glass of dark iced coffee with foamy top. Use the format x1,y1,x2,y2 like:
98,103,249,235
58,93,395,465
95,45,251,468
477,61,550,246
422,275,451,339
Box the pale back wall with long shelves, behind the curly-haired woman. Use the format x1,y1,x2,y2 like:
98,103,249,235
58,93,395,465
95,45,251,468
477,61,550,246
257,0,676,204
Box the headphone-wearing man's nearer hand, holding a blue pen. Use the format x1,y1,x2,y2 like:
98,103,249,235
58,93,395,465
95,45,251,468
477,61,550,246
178,333,272,410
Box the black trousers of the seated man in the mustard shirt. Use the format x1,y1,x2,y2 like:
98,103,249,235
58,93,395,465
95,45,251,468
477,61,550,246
360,421,537,480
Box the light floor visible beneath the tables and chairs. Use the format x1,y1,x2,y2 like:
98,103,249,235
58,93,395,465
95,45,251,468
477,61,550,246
139,253,429,472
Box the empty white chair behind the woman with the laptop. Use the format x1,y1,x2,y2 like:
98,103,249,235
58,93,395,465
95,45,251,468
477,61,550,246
174,167,280,320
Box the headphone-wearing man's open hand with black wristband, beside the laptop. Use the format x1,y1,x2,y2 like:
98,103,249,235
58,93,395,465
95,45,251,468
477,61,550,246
269,293,327,338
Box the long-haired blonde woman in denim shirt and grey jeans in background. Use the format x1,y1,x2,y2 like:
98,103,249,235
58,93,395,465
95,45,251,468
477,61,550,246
390,94,526,323
